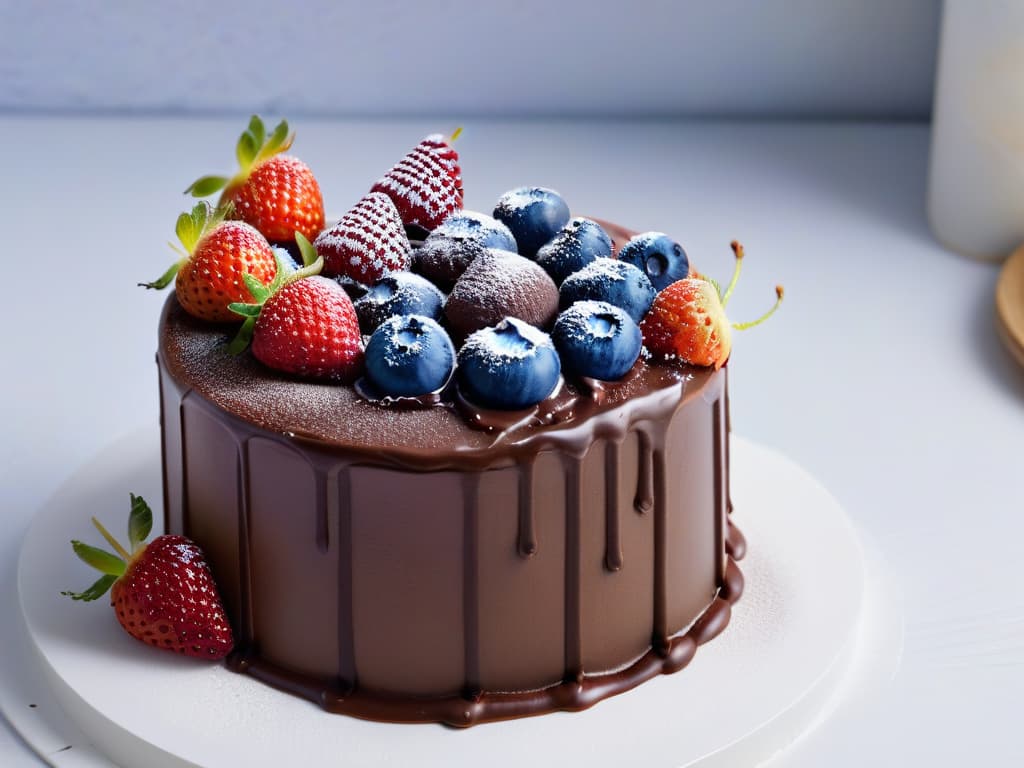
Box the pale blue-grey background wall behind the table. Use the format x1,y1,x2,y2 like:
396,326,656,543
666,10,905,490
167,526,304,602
0,0,939,119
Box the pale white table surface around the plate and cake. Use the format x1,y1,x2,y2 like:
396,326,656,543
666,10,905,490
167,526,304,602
0,117,1024,768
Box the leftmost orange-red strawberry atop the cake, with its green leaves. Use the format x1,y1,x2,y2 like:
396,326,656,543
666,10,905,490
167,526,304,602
139,203,278,323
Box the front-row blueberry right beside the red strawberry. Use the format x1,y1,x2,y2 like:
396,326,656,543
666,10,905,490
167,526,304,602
366,314,455,397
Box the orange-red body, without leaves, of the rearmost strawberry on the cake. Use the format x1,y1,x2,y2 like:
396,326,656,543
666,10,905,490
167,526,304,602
223,155,324,243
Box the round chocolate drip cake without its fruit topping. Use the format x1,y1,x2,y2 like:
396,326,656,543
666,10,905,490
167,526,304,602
157,225,743,726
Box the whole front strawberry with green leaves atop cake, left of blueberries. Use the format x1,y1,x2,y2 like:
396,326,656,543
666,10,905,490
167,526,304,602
228,232,362,383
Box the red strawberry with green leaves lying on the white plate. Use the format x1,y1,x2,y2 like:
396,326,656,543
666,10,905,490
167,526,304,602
60,495,232,659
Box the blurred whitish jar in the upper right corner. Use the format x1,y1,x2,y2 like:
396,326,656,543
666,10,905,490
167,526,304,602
928,0,1024,260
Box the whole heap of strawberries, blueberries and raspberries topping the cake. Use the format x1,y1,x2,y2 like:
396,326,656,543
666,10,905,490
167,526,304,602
144,117,782,411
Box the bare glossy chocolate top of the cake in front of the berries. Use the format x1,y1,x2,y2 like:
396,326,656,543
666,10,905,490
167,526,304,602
159,295,724,464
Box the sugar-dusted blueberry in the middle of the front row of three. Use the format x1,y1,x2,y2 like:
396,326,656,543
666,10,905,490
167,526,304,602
460,317,561,411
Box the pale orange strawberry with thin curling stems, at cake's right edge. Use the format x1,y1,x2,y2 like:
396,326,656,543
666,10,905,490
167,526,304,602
640,241,782,370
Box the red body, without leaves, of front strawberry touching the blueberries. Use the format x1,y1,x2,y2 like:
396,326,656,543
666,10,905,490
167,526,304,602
252,276,362,383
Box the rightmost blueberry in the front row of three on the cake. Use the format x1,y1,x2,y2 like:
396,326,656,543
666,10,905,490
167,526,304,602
551,301,643,381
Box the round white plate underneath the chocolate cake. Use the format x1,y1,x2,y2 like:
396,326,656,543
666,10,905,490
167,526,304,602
8,430,870,768
